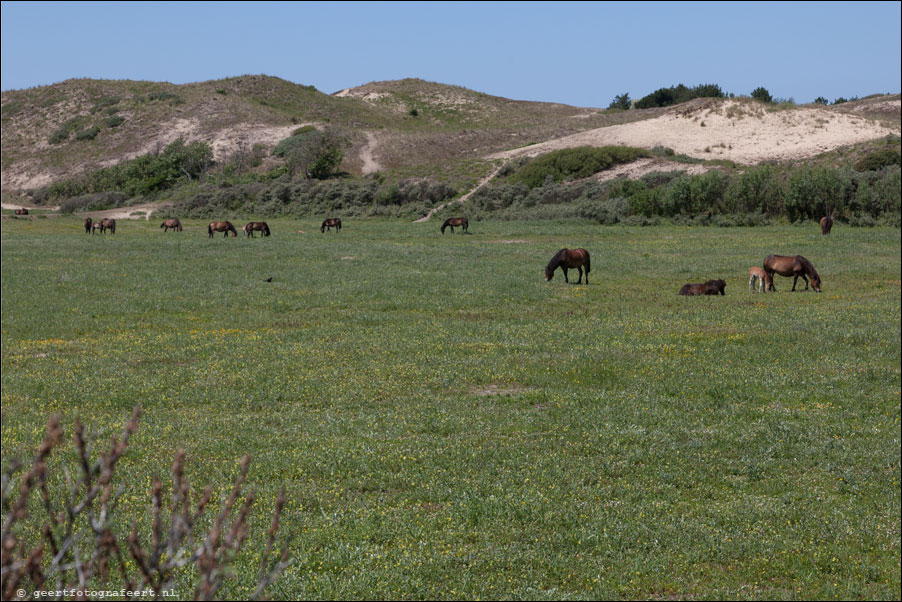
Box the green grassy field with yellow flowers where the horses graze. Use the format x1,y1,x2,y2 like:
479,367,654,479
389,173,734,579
2,218,900,599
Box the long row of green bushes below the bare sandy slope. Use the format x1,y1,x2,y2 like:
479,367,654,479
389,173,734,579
470,165,902,225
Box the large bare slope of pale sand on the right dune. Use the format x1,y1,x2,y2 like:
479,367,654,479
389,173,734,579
489,101,899,164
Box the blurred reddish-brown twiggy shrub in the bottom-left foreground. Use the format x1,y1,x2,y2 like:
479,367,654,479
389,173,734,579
0,408,289,600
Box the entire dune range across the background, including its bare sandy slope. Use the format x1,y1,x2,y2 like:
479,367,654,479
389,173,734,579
2,75,900,209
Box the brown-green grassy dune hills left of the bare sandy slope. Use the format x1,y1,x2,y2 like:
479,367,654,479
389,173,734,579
2,76,644,190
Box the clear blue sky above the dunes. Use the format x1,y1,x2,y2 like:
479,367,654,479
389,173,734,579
0,2,902,107
